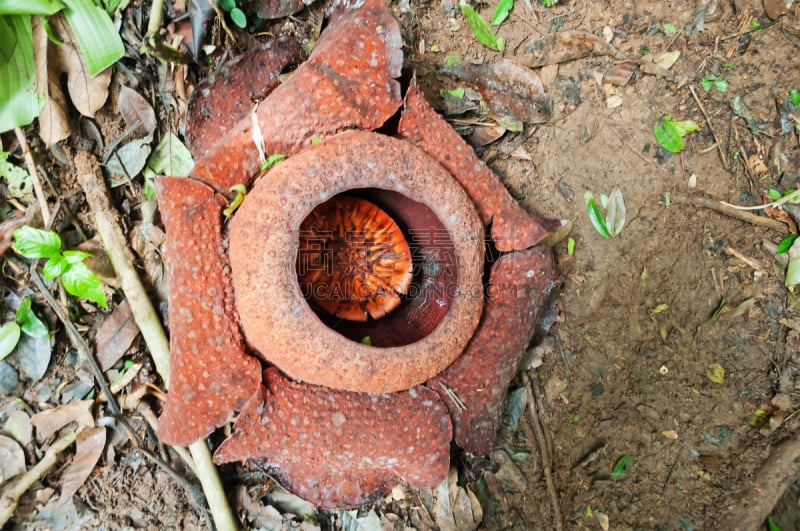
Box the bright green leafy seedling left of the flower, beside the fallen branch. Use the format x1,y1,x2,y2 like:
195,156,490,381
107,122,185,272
12,225,108,309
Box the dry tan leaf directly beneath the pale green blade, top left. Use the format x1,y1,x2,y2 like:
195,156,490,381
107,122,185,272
48,13,111,118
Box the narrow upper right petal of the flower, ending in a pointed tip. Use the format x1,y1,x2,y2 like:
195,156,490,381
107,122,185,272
398,86,561,251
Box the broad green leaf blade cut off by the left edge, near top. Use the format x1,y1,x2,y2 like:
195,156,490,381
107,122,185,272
0,15,44,133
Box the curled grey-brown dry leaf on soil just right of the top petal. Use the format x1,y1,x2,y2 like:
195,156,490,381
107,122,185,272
442,59,552,124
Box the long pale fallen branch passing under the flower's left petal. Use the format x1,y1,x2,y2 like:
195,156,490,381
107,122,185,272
75,152,238,530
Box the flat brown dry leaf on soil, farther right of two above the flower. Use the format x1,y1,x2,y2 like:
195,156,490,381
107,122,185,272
517,30,619,68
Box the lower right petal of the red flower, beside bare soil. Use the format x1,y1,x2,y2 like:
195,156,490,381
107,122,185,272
428,245,555,455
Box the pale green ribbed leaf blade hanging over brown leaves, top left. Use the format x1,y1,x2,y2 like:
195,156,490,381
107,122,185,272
64,0,125,76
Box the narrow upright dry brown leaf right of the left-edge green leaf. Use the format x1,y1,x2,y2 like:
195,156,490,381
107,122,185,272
33,17,71,147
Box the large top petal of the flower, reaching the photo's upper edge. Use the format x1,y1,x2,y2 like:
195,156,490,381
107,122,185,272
185,0,403,191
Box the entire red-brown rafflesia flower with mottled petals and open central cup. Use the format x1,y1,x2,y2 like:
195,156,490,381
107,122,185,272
158,0,558,507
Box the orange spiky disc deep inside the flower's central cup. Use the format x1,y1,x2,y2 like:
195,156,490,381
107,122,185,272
297,196,412,321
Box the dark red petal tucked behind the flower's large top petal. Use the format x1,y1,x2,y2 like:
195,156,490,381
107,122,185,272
184,38,303,160
